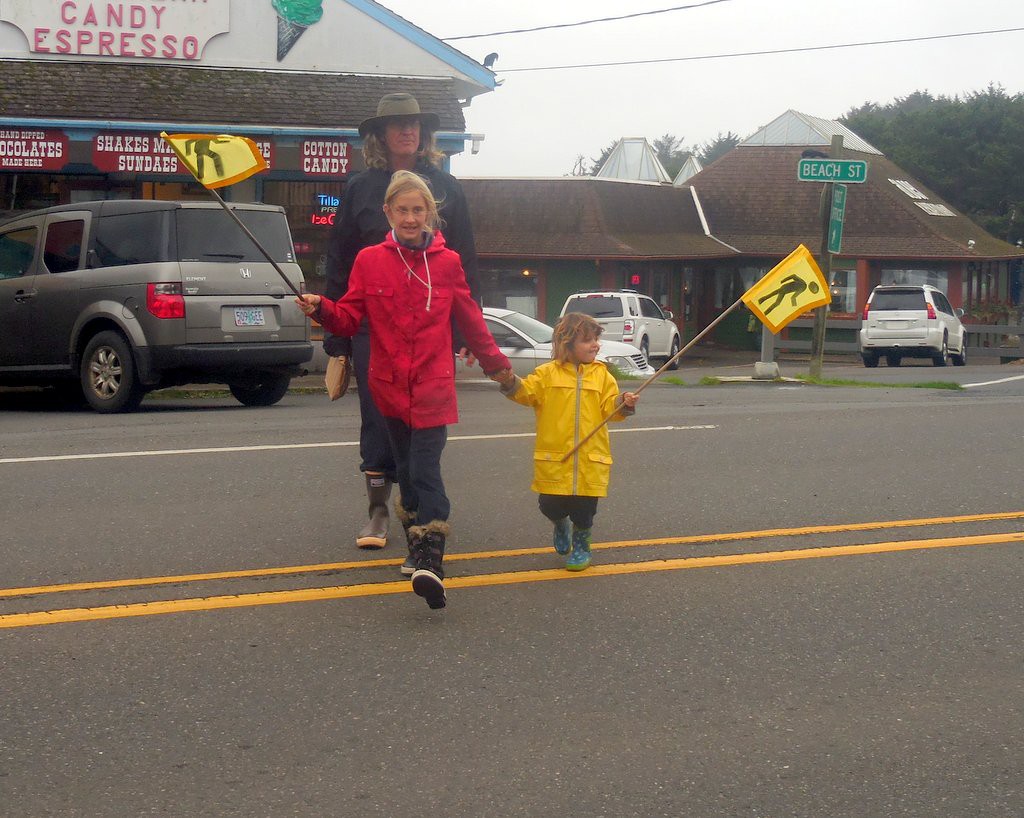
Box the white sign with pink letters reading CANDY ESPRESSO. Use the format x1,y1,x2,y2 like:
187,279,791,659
0,0,229,60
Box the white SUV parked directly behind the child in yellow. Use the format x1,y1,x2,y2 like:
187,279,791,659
558,290,680,370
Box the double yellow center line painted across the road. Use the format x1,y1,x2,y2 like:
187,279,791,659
0,511,1024,629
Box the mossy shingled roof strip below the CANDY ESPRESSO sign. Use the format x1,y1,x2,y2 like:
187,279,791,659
0,59,466,132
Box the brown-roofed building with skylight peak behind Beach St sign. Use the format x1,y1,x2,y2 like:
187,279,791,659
462,112,1024,352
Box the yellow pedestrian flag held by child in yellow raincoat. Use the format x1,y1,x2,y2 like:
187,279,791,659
740,245,831,333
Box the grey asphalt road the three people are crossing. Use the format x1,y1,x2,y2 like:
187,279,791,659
0,365,1024,816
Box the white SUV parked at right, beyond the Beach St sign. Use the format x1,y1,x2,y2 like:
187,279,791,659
859,284,967,367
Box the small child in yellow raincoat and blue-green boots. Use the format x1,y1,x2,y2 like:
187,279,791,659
492,312,639,571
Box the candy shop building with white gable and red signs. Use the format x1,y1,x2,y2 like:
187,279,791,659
0,0,496,290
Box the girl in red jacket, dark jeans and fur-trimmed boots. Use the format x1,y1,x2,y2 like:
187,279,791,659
296,171,510,608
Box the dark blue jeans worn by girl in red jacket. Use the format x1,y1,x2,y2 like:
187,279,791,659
384,418,452,525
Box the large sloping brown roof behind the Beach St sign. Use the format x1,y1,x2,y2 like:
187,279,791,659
688,146,1024,260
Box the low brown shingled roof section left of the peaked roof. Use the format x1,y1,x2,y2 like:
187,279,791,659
461,177,735,259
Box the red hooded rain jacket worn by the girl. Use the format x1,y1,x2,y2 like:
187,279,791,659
318,232,511,429
